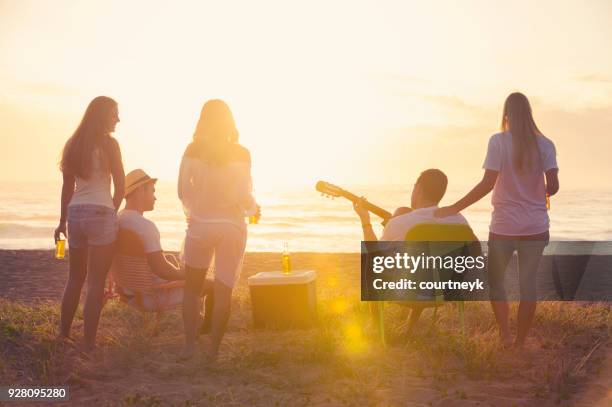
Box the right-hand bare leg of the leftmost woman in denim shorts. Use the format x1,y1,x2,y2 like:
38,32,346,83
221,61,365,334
83,243,115,351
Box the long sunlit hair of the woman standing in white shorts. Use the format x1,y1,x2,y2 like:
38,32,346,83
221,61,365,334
185,99,238,165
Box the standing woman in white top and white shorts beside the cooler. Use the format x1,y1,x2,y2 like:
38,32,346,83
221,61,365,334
178,99,259,359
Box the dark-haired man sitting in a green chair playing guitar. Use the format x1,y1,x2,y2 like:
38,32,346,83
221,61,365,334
353,169,478,331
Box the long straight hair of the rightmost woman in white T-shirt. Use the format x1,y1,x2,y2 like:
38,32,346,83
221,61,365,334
501,92,542,172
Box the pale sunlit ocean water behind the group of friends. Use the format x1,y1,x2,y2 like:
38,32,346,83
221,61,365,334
0,181,612,252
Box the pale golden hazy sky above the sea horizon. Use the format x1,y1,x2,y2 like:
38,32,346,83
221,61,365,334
0,0,612,188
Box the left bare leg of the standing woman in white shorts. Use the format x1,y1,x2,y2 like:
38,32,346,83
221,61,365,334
181,266,207,359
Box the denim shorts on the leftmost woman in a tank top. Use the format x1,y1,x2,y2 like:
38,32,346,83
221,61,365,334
68,204,119,249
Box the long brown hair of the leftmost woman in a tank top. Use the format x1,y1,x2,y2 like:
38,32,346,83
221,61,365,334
60,96,117,179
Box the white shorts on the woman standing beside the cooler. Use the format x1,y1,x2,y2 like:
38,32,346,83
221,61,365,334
181,222,247,288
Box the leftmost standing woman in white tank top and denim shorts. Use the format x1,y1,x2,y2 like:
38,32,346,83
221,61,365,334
54,96,125,352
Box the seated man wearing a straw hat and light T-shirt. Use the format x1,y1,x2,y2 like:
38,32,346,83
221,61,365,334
118,169,212,332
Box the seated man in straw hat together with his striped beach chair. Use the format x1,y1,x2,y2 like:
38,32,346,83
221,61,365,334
117,169,213,332
